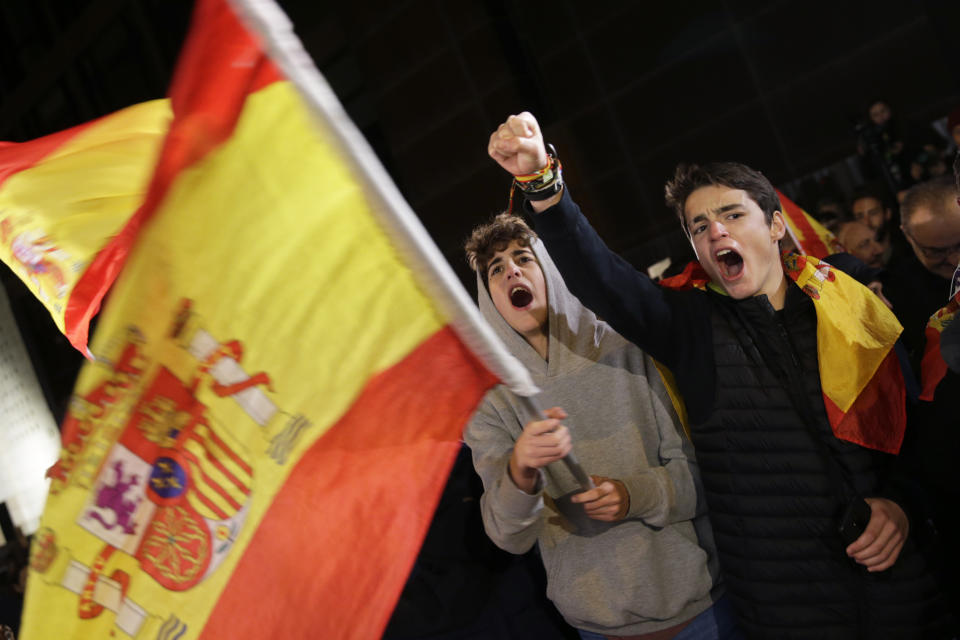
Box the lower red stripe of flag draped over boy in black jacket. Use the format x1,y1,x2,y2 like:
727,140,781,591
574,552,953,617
823,349,907,454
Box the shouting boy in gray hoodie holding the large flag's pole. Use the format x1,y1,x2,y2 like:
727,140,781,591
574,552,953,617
465,214,739,640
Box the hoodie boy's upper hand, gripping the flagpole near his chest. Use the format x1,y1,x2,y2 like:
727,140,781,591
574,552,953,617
510,407,573,493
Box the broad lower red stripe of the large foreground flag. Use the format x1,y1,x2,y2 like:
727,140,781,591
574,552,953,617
201,328,496,639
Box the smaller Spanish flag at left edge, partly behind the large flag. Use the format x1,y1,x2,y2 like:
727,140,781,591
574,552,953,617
0,100,171,354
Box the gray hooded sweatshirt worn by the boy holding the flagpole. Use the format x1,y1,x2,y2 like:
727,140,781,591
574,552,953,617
465,240,720,636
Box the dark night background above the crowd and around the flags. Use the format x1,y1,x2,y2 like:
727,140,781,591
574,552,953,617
0,0,960,418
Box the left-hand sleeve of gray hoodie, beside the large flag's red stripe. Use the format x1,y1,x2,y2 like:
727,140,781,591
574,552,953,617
464,400,544,554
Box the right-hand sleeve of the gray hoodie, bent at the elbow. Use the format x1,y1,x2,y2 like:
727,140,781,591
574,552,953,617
623,358,706,527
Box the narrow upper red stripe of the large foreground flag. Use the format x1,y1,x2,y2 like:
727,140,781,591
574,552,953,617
63,0,281,353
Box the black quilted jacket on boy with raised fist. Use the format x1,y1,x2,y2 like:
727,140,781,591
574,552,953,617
536,195,945,640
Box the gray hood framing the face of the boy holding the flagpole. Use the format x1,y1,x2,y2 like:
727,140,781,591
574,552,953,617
477,239,627,386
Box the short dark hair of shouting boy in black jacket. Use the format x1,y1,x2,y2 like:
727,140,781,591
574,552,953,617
664,162,780,235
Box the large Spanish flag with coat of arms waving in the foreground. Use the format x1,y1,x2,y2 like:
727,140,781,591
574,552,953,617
23,0,533,640
